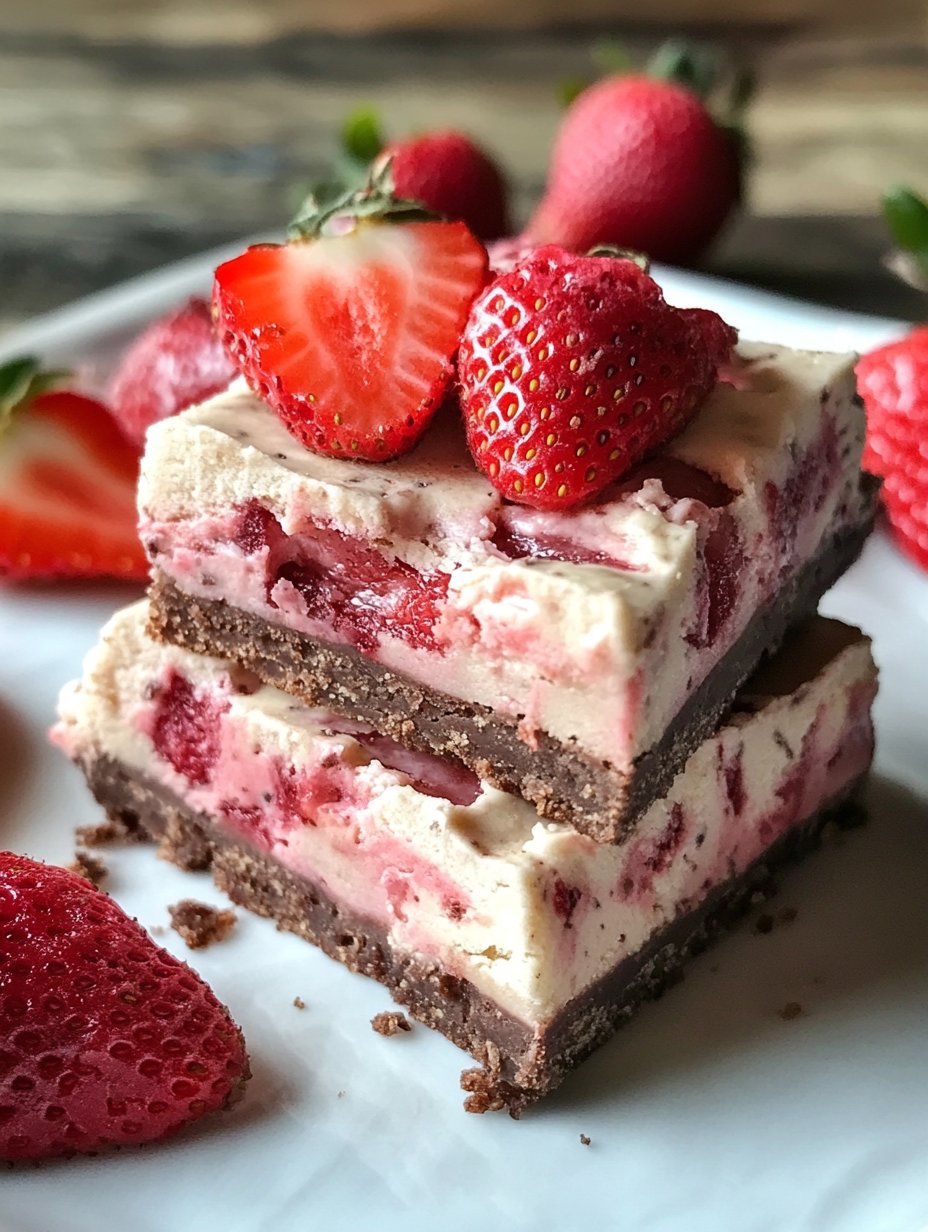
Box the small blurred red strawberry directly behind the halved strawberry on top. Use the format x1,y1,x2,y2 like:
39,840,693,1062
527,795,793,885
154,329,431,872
378,129,509,240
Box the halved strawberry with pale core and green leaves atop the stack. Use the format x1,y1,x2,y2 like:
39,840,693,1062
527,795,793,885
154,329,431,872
213,175,487,461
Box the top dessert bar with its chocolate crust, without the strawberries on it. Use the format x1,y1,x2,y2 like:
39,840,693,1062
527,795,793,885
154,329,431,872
139,344,873,841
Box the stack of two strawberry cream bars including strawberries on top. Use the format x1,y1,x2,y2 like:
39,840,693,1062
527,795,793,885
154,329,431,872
57,224,876,1114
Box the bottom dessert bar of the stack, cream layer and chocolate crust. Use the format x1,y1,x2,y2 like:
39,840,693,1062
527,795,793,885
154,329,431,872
55,605,875,1112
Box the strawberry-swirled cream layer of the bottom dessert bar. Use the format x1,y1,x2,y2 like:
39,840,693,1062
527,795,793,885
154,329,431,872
54,605,876,1024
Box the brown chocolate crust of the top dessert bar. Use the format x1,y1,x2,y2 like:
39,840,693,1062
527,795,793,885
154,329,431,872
149,495,871,843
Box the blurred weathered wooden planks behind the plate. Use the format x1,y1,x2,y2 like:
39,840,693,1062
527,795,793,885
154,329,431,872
0,12,928,326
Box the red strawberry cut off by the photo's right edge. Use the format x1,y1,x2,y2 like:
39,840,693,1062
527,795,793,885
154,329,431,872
857,325,928,569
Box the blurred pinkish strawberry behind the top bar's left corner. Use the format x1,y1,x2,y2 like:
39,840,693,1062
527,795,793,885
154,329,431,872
110,299,235,448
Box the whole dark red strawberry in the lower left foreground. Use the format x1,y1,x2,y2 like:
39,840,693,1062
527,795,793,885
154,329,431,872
0,851,249,1159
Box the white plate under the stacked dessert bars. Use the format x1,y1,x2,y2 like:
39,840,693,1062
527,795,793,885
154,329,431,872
0,254,928,1232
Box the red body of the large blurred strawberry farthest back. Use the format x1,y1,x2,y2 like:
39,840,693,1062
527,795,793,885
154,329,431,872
526,75,741,264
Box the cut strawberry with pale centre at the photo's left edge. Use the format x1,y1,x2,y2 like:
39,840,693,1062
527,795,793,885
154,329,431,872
0,360,148,579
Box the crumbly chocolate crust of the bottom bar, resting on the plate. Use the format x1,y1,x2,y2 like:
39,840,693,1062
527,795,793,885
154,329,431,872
83,756,861,1116
